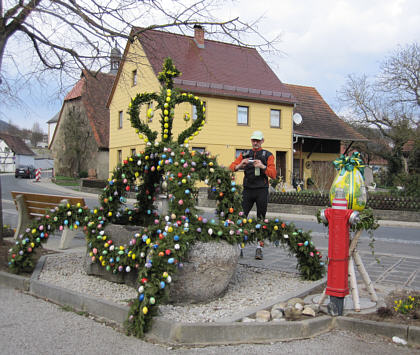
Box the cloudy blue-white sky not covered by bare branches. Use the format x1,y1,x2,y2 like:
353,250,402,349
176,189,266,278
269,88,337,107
0,0,420,132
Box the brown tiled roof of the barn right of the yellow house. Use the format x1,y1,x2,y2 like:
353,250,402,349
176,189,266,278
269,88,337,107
285,84,367,141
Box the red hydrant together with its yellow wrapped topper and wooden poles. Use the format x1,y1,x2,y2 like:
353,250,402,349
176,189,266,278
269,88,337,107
319,152,378,316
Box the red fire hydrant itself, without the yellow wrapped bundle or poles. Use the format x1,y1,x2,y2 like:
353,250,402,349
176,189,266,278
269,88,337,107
321,189,359,315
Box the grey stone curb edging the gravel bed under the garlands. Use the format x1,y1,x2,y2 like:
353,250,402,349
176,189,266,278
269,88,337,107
0,255,420,346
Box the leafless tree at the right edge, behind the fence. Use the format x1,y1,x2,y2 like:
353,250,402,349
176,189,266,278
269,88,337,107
339,43,420,186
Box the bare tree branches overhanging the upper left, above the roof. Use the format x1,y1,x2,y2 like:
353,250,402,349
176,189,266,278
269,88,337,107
0,0,278,103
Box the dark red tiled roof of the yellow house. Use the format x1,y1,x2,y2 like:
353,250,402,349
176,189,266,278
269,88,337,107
133,28,295,104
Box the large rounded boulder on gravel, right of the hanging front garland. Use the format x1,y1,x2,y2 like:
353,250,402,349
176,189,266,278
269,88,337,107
169,241,239,303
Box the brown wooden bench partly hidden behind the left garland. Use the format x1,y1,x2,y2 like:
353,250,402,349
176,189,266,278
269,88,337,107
11,191,86,249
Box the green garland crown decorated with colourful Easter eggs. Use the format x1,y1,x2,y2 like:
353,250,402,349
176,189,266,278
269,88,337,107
9,58,325,337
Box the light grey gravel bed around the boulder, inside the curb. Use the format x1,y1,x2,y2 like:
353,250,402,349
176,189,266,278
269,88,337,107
40,254,312,323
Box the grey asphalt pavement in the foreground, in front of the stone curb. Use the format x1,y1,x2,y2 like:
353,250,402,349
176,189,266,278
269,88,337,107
0,285,420,355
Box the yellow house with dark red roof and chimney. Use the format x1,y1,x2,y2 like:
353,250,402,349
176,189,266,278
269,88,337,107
108,26,295,183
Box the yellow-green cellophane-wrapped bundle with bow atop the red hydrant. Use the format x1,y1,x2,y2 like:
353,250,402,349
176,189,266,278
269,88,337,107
330,152,367,211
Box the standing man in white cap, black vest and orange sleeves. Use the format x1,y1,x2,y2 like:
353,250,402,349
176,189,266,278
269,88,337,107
229,131,276,260
